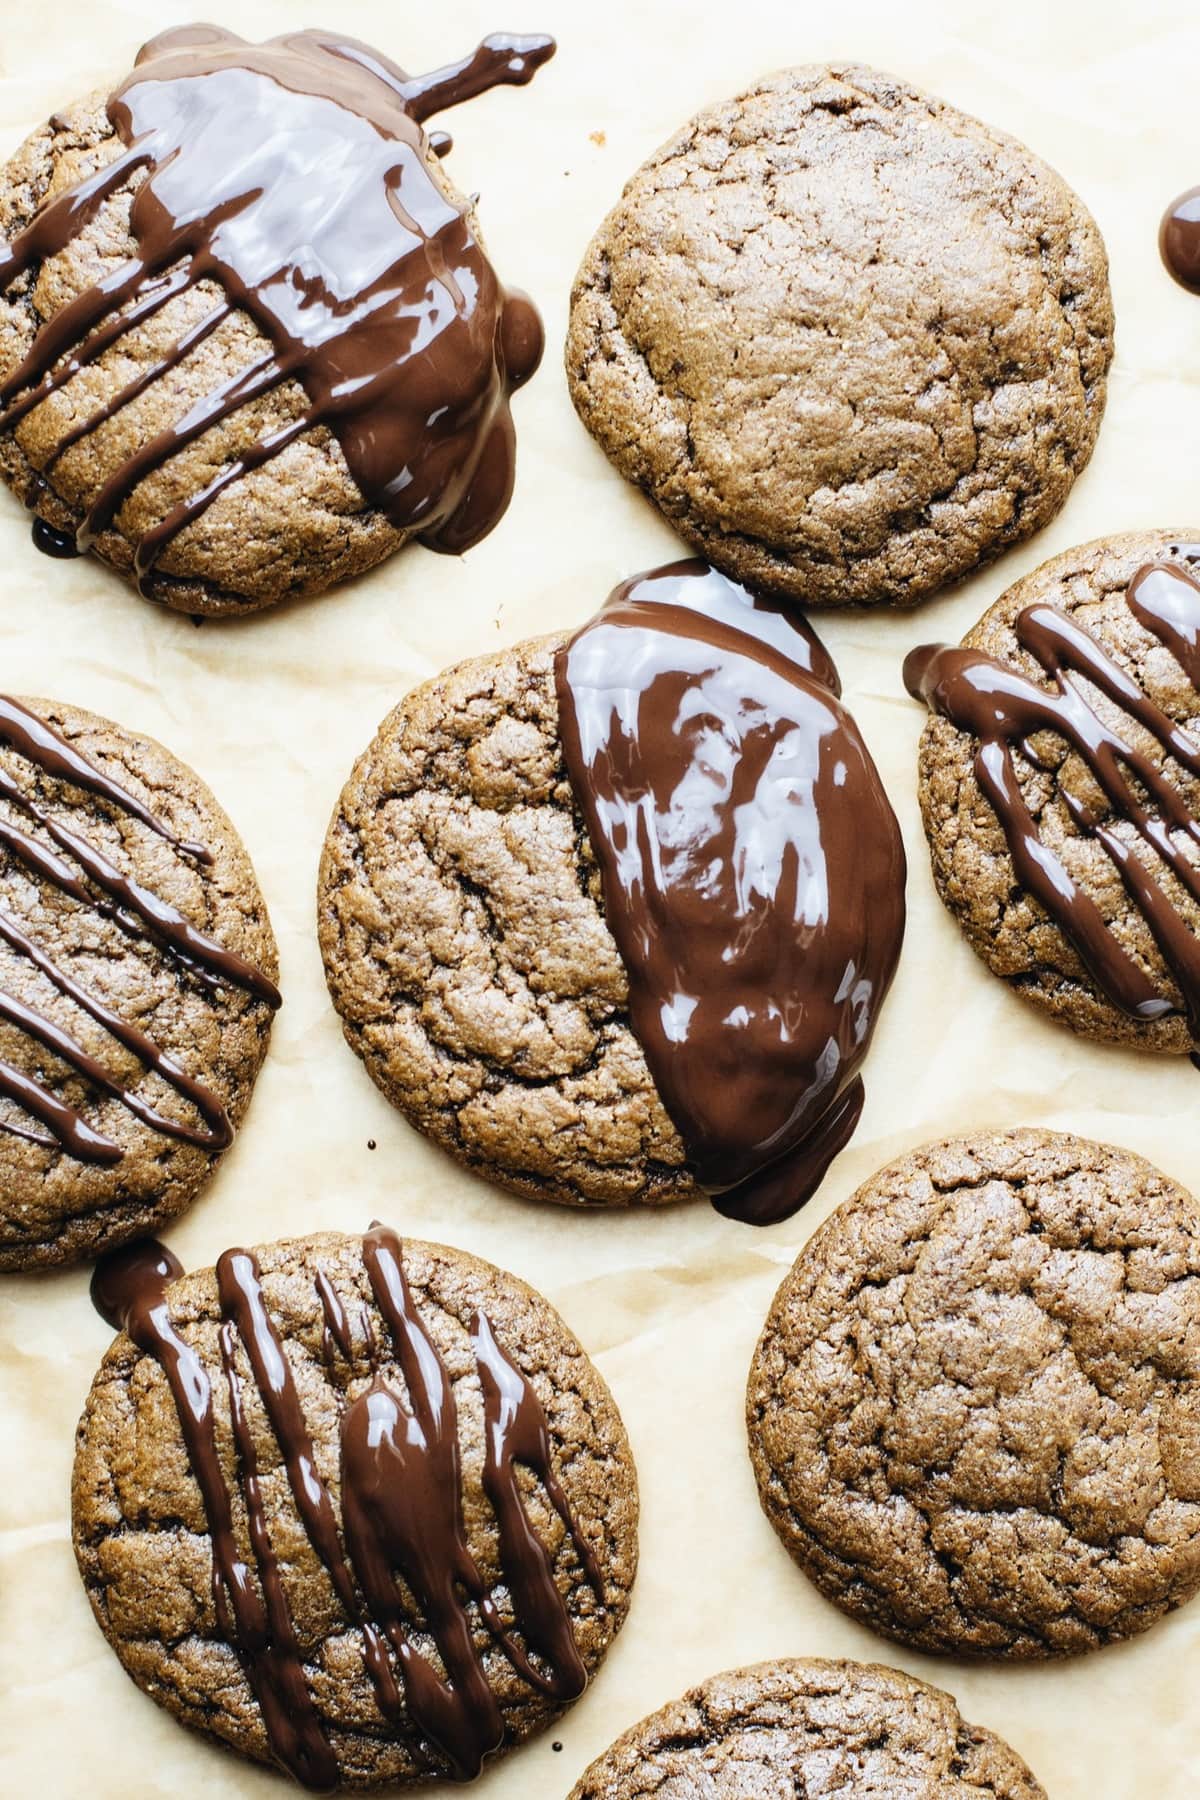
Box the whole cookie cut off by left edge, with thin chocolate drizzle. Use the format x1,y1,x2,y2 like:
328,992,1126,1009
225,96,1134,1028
0,697,279,1269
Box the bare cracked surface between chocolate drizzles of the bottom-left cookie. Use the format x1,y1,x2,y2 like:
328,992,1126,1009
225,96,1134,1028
72,1233,637,1789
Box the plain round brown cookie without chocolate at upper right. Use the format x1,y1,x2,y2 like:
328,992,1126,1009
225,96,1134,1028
567,65,1114,607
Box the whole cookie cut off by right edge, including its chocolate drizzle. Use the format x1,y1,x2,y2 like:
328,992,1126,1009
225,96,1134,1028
905,531,1200,1053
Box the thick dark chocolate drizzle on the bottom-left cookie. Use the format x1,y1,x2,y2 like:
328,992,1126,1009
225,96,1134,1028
92,1224,604,1793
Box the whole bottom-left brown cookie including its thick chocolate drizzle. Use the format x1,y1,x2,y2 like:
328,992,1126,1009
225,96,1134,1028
72,1226,637,1793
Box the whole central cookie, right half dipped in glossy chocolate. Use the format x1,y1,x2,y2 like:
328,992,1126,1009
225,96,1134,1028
318,563,905,1222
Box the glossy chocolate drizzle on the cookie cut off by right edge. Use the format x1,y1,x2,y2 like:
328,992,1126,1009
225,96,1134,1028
905,563,1200,1046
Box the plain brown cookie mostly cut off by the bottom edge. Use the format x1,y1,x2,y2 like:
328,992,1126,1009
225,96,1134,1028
570,1658,1045,1800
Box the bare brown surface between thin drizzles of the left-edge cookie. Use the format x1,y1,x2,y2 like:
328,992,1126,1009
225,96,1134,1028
0,700,279,1269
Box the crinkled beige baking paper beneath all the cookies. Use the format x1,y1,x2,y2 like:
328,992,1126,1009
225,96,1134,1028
0,0,1200,1800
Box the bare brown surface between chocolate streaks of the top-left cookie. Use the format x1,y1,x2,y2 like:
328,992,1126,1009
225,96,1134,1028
0,94,405,614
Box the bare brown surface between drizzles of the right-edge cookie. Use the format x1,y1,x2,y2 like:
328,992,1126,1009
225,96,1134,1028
919,531,1200,1053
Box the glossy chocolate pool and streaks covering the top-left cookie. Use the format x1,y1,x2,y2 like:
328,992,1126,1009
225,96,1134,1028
0,25,554,589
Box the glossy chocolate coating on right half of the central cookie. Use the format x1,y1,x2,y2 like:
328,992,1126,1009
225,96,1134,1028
556,562,905,1224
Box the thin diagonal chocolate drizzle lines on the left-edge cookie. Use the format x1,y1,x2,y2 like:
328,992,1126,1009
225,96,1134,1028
0,697,279,1165
